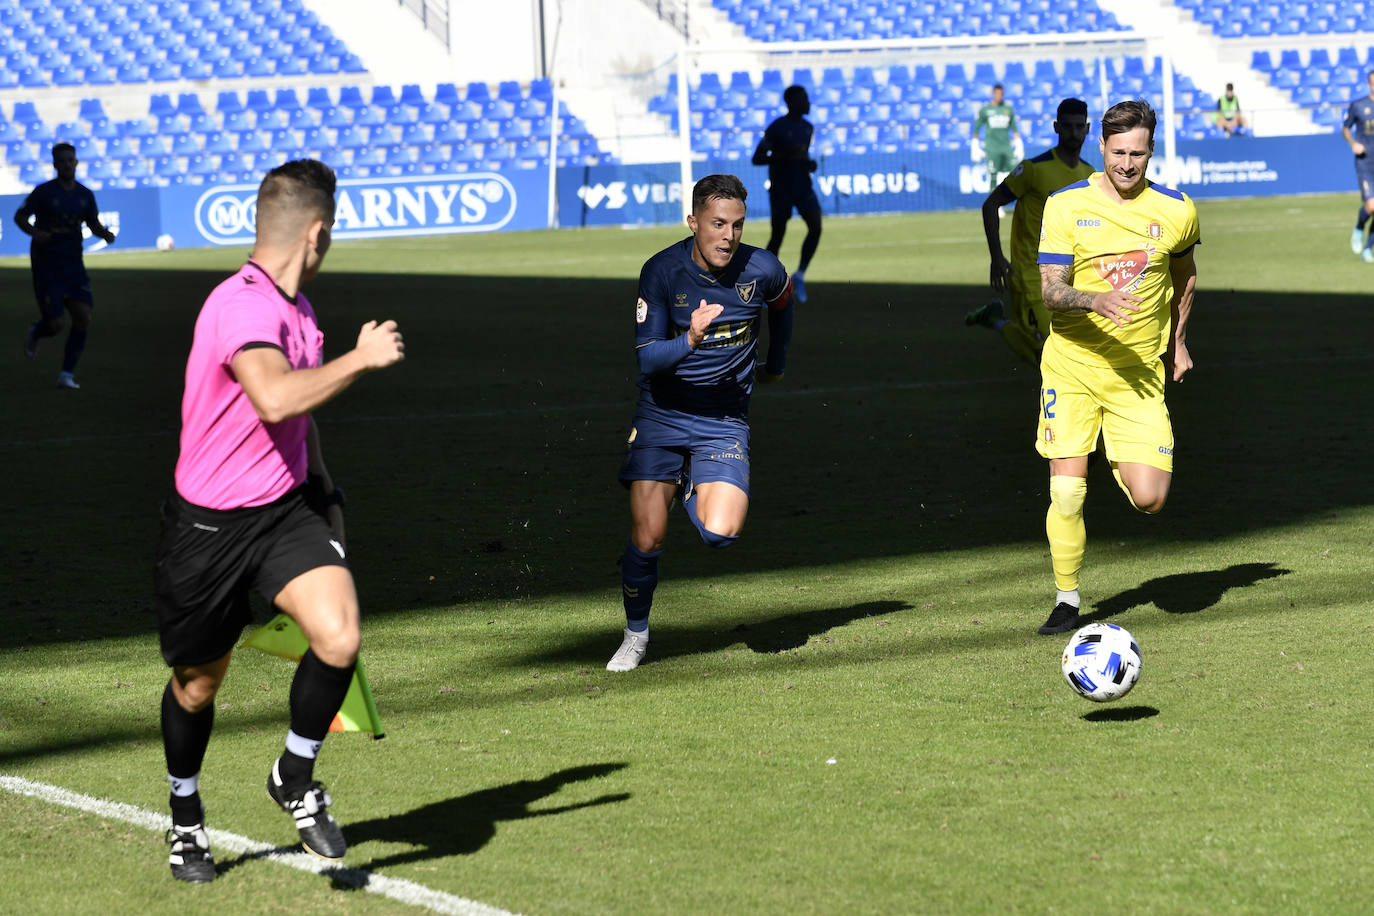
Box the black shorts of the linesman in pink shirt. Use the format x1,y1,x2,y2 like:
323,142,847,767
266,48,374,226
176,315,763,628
154,486,348,666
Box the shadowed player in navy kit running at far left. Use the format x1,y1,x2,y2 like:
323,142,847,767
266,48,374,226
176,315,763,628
14,143,114,389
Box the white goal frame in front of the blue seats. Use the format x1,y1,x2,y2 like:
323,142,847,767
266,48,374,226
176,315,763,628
676,32,1178,217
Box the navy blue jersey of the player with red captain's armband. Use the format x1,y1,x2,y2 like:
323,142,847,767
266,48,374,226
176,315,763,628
635,236,791,416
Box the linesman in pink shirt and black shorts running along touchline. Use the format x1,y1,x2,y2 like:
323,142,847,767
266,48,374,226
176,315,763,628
155,159,405,882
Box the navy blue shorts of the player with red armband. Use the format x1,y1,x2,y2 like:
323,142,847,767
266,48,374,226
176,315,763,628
620,404,749,494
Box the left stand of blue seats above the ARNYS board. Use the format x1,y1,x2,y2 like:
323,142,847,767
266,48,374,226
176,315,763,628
0,0,613,190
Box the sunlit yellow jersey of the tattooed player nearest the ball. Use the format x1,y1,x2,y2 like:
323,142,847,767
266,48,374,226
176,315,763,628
1039,172,1201,367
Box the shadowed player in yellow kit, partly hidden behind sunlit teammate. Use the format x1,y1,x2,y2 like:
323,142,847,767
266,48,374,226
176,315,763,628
965,99,1092,365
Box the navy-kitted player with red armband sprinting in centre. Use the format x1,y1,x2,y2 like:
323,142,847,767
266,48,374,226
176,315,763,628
606,174,793,672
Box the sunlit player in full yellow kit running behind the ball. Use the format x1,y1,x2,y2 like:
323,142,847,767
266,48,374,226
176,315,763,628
1036,100,1201,634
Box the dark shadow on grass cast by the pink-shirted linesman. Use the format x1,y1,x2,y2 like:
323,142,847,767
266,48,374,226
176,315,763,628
344,764,629,869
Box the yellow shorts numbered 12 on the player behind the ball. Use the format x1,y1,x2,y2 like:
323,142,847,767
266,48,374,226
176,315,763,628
1036,338,1173,472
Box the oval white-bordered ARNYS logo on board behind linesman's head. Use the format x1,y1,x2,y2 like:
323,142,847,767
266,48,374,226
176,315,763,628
195,172,517,244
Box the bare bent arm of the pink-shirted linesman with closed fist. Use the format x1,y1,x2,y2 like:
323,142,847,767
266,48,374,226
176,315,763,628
232,321,405,423
